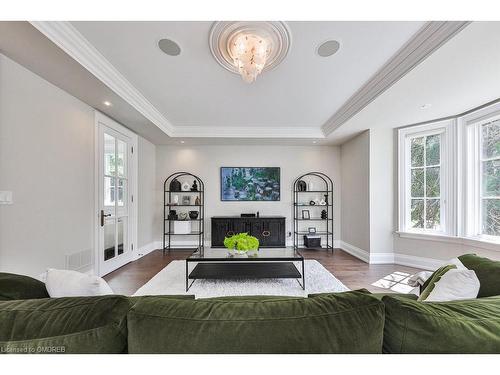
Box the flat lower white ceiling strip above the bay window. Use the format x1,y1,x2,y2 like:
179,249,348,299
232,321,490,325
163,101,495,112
329,22,500,144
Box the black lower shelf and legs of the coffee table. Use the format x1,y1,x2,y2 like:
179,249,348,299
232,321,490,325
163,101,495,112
186,262,305,291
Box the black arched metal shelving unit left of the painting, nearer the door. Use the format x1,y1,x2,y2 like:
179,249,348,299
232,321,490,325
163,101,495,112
163,172,205,253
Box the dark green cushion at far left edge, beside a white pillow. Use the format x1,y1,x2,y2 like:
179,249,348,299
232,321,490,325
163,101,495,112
0,272,49,301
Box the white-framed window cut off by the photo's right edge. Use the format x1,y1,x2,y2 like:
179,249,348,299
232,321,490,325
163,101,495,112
461,105,500,242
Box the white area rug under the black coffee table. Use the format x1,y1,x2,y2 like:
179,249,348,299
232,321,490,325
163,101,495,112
134,260,349,298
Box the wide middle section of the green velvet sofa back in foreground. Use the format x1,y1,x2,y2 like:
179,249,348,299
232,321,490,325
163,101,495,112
127,291,384,353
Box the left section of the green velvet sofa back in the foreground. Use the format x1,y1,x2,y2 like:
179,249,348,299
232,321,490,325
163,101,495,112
0,296,132,353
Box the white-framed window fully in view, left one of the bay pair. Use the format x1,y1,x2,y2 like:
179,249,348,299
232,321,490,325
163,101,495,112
399,120,455,235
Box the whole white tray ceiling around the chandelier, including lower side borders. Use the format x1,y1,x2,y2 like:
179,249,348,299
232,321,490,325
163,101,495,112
0,22,500,145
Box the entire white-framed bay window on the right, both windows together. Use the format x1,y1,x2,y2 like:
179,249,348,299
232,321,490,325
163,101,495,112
398,101,500,250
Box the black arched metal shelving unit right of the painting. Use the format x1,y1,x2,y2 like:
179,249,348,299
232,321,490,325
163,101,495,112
293,172,334,253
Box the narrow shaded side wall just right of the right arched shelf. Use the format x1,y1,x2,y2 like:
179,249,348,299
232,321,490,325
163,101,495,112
340,131,370,252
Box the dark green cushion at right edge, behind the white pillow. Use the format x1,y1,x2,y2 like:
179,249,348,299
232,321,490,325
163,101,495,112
458,254,500,298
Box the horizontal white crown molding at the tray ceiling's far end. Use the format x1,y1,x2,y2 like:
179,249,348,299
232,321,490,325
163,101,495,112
173,125,325,139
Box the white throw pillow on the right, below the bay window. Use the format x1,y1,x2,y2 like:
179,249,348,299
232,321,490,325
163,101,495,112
424,269,480,302
